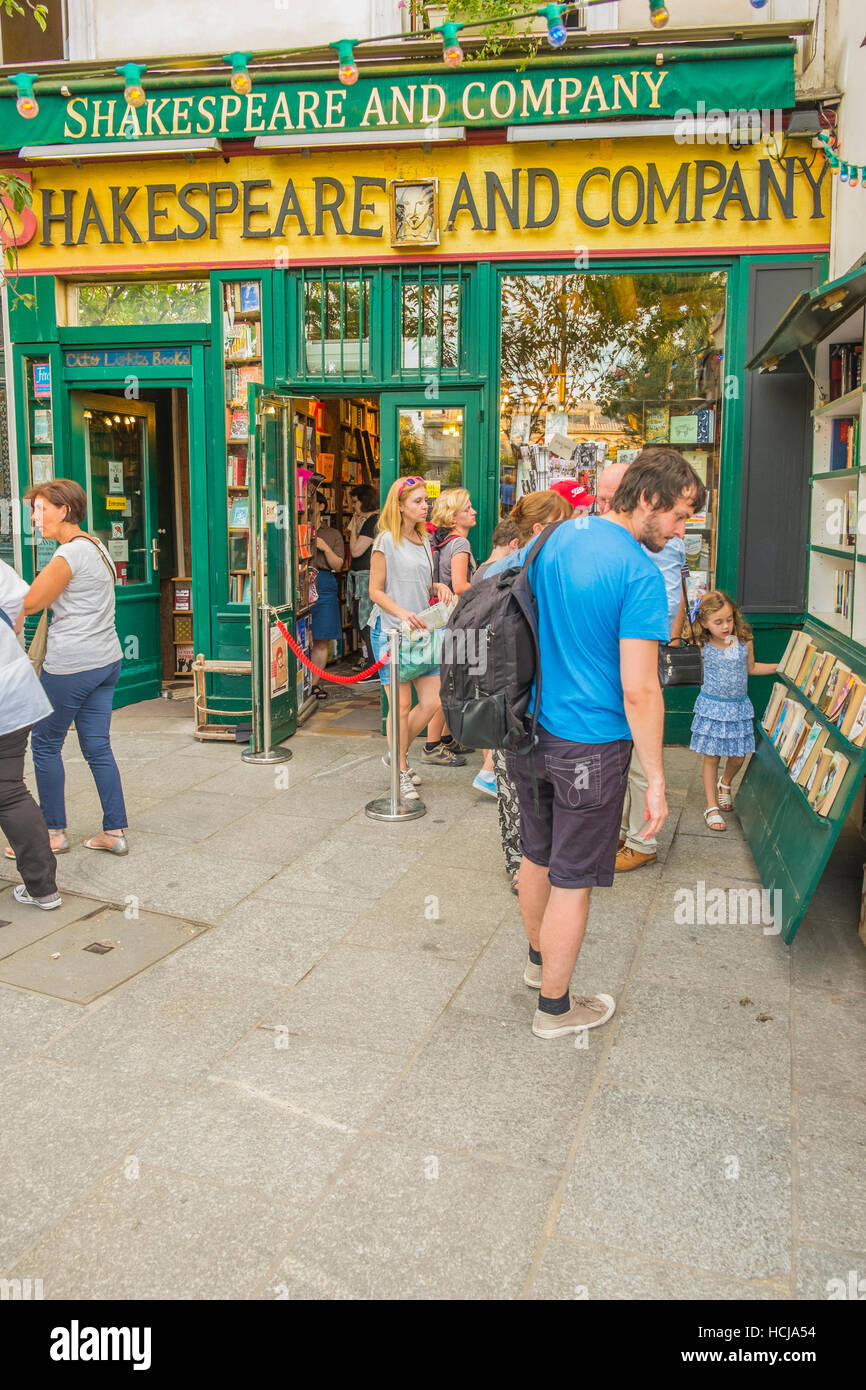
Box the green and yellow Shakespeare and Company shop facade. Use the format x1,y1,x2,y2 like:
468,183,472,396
4,43,830,741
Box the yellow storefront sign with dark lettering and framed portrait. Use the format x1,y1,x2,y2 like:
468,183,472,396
11,138,831,274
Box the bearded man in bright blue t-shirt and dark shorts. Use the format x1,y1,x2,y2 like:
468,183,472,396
507,446,705,1038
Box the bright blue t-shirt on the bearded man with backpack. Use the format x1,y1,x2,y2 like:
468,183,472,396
525,517,670,744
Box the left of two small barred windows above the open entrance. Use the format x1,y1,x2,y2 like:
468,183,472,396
300,270,370,377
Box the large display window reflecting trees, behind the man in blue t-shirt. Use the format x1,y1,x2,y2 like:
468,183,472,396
499,271,727,599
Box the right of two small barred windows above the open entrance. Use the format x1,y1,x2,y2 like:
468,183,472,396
398,268,466,371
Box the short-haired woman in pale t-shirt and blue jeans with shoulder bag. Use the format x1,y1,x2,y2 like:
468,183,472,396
10,478,128,855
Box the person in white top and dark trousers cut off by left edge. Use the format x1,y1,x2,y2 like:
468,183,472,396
0,560,63,912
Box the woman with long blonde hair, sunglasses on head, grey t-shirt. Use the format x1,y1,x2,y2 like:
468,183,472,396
370,478,450,801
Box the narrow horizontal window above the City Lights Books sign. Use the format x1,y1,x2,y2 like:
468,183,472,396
67,279,210,328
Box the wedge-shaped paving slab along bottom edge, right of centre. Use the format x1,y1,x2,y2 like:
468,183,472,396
530,1236,791,1302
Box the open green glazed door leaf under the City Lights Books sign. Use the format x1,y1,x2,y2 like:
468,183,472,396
70,391,163,706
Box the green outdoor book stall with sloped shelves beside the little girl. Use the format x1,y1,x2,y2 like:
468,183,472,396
737,268,866,941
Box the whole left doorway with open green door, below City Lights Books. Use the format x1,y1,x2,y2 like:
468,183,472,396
70,386,195,705
